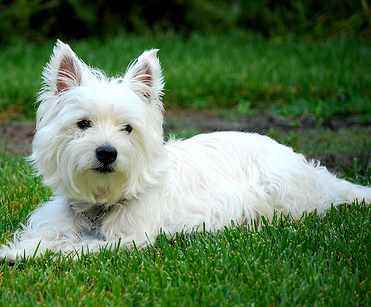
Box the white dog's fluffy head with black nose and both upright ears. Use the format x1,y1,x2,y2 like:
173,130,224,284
31,41,163,203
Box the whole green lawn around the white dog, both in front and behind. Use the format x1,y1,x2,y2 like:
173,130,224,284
0,33,371,306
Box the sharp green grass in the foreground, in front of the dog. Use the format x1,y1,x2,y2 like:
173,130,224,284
0,147,371,306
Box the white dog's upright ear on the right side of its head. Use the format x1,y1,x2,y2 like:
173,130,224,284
124,49,164,99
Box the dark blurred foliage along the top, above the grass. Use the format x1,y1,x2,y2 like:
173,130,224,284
0,0,371,42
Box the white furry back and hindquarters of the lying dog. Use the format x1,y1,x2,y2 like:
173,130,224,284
164,132,371,228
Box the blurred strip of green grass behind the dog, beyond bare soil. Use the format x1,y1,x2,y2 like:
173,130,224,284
0,33,371,121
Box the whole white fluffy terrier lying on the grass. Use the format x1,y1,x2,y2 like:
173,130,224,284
0,41,371,261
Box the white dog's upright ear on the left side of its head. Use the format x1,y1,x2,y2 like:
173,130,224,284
43,40,84,95
